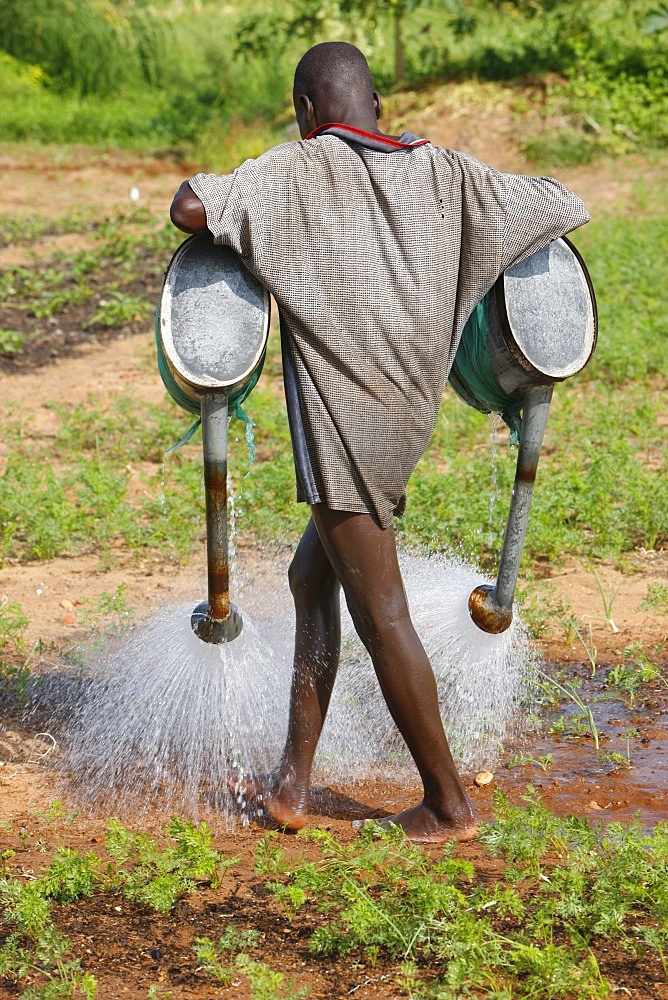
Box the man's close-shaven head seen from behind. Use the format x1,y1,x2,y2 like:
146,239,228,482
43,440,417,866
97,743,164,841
292,42,381,137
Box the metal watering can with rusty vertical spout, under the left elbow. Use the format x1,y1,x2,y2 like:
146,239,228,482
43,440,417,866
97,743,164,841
156,233,270,643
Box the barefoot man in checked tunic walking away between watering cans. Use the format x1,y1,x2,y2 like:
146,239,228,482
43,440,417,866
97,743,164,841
172,42,588,843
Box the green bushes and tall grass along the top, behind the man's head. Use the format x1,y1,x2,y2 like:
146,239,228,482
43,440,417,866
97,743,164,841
0,0,668,162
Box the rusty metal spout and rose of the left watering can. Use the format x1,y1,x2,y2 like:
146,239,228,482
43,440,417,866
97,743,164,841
190,389,243,644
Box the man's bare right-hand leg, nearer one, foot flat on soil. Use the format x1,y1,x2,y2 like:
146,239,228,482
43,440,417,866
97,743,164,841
313,505,476,843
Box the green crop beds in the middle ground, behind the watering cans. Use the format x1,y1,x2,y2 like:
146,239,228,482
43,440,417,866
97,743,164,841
0,181,668,566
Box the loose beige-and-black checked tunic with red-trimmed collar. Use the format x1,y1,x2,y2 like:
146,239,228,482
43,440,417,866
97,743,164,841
190,126,589,527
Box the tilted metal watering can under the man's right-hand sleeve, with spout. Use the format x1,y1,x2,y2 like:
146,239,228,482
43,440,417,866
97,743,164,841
449,238,598,633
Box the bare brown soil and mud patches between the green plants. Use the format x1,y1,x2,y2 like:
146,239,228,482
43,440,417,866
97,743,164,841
0,119,668,1000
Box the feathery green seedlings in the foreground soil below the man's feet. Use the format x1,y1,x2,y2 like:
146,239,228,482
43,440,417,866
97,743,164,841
5,804,668,1000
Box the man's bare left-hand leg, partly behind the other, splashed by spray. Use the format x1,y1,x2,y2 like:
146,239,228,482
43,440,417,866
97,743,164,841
237,520,341,830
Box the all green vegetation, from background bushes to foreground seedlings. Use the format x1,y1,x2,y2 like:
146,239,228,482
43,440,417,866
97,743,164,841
0,0,668,1000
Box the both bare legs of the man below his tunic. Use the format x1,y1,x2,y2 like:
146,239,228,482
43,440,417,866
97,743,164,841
235,505,476,843
